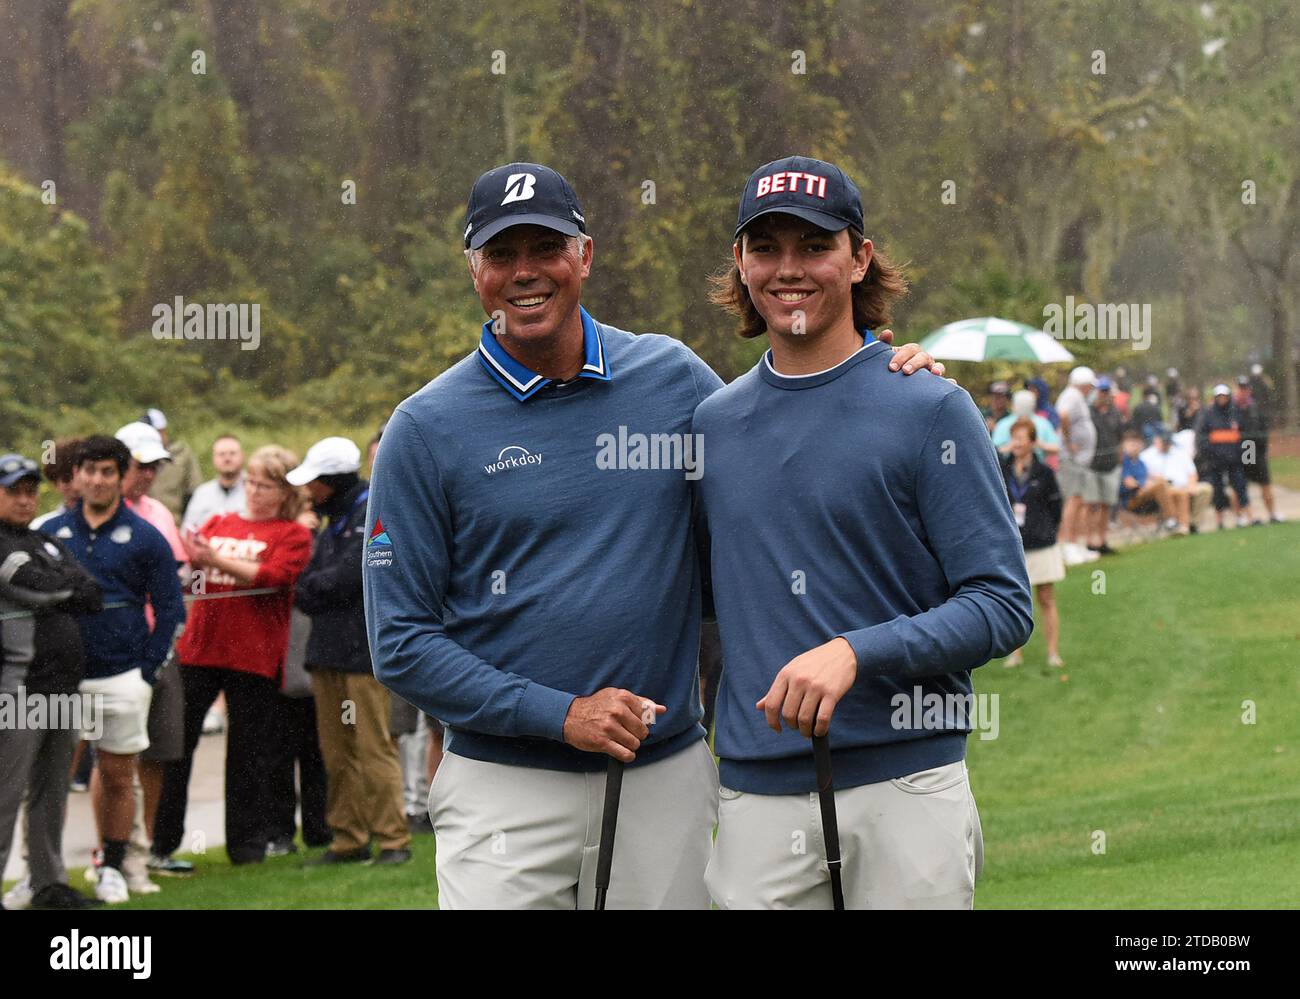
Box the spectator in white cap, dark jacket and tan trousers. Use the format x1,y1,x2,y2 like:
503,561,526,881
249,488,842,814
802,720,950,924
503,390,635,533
287,437,411,866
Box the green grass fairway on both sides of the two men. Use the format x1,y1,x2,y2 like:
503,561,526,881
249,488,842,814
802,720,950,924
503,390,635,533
12,523,1300,909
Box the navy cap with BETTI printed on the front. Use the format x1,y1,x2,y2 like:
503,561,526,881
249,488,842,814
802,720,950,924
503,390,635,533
736,156,866,238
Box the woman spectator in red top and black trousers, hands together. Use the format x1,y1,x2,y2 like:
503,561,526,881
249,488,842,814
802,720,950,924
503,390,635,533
153,445,312,864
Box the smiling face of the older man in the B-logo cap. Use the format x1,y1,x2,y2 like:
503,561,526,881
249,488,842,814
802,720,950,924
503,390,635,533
471,225,592,346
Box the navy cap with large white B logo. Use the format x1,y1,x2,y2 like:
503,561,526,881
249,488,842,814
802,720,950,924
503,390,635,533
465,163,586,250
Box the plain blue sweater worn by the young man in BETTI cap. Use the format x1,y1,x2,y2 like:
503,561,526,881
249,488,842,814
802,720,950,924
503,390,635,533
694,342,1034,793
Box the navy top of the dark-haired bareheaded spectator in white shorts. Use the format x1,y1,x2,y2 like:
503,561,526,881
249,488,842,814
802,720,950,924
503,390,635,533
40,501,185,683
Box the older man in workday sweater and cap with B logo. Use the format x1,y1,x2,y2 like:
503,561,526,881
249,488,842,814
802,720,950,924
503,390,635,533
364,163,946,908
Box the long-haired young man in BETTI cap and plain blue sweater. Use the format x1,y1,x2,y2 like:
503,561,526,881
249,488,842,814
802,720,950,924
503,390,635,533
696,157,1034,908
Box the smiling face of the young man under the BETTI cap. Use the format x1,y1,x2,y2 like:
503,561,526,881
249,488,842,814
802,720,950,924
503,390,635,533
735,212,871,337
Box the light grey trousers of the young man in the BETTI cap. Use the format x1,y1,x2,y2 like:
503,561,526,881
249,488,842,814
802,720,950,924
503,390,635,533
706,758,984,909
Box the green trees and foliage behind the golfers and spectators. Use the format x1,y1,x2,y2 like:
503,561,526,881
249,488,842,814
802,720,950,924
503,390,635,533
0,0,1300,438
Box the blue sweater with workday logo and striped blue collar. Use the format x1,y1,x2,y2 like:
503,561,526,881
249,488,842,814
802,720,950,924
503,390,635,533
363,312,722,771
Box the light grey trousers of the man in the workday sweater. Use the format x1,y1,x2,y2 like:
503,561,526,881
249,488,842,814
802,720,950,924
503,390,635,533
429,740,718,909
